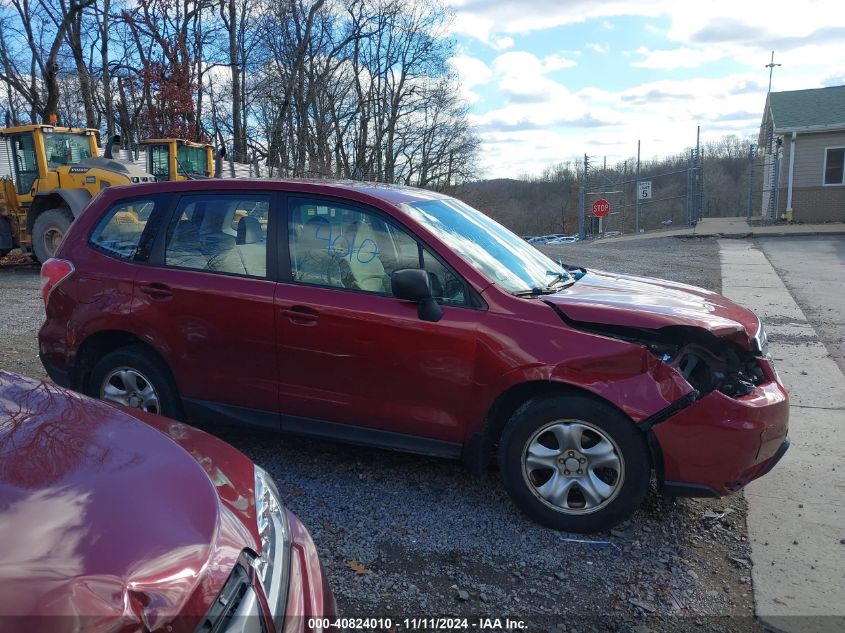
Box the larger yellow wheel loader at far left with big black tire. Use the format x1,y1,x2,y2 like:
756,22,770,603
0,125,155,262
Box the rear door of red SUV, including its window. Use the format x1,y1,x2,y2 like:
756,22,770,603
133,191,279,428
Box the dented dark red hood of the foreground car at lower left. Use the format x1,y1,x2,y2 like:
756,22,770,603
0,371,255,631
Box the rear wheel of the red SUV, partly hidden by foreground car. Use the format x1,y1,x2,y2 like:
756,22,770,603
86,346,182,419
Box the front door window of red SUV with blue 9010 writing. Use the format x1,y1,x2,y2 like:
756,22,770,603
288,199,465,305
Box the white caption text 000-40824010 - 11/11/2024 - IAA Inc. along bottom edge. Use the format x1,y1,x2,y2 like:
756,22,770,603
308,617,528,632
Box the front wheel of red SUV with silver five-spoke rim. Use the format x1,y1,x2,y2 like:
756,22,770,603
499,395,651,533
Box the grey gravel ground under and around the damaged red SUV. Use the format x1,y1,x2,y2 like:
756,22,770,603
0,238,761,633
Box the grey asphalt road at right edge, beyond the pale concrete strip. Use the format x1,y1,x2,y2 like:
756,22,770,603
757,235,845,373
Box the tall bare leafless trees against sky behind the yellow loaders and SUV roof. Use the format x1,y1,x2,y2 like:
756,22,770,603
0,0,479,189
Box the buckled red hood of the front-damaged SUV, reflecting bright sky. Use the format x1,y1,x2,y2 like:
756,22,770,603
543,270,760,350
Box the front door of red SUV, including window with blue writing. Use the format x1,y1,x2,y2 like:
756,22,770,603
275,196,479,446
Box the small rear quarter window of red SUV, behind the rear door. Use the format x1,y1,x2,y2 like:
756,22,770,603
89,199,156,260
